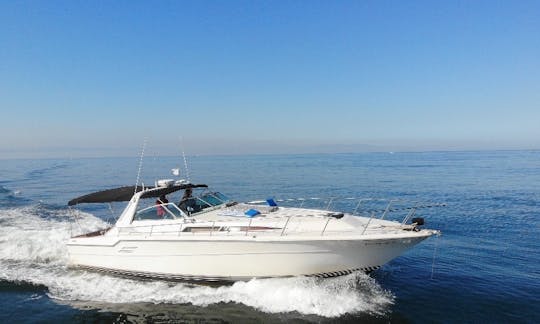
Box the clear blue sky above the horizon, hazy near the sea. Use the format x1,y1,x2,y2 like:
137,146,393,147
0,0,540,159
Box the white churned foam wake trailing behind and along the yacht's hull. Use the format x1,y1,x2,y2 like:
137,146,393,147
0,206,393,317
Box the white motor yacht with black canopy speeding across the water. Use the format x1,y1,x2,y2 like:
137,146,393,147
67,180,439,282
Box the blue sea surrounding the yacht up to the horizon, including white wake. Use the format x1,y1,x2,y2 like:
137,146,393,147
0,151,540,323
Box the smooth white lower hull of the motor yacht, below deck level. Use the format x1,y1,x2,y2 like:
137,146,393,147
68,232,431,281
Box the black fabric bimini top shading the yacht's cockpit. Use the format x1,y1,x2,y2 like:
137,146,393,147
68,183,208,206
